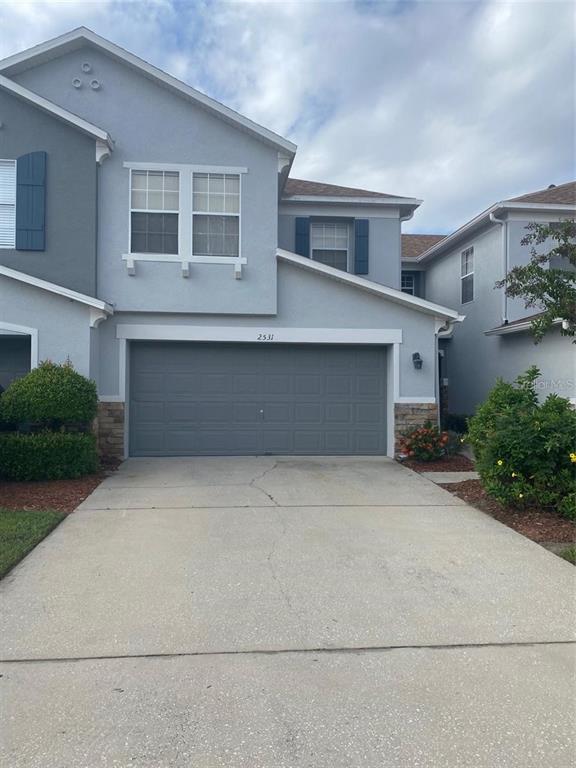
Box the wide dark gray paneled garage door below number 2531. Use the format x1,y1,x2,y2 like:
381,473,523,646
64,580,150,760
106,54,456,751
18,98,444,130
129,342,386,456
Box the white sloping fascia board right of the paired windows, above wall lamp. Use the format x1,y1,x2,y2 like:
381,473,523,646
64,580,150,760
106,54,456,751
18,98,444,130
276,248,464,322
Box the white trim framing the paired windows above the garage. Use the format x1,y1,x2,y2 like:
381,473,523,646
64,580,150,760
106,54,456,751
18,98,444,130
122,162,248,279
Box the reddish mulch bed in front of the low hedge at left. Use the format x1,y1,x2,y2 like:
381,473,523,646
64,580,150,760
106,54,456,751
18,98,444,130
0,472,107,512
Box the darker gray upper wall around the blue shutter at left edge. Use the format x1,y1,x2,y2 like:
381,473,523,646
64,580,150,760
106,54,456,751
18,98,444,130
0,90,97,295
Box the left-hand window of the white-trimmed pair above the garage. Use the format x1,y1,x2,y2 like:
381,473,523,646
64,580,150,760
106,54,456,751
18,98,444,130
130,170,180,254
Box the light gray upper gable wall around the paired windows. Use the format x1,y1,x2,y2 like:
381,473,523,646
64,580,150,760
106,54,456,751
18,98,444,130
14,46,278,314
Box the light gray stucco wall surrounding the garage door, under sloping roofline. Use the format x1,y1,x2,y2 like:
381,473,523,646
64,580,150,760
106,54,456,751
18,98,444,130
97,263,436,399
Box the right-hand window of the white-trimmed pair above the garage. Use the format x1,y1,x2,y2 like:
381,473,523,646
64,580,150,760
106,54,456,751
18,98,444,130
192,173,240,256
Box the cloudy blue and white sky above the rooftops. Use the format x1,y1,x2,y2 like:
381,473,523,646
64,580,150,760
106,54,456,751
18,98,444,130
0,0,576,233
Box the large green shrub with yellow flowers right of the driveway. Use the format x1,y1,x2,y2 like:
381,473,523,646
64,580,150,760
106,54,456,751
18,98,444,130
467,367,576,508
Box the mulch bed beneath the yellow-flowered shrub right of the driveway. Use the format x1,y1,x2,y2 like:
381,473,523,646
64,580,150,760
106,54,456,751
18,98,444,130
440,480,576,544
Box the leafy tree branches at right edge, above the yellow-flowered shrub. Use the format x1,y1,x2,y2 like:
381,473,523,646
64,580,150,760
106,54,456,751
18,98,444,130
496,219,576,343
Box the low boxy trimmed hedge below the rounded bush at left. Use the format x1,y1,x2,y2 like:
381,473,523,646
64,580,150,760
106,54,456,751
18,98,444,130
0,432,98,480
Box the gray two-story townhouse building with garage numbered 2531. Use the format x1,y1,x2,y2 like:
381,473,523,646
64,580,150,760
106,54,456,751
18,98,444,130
0,29,461,456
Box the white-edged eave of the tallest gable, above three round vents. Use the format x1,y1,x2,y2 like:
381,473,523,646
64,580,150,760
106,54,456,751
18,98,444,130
0,27,296,155
